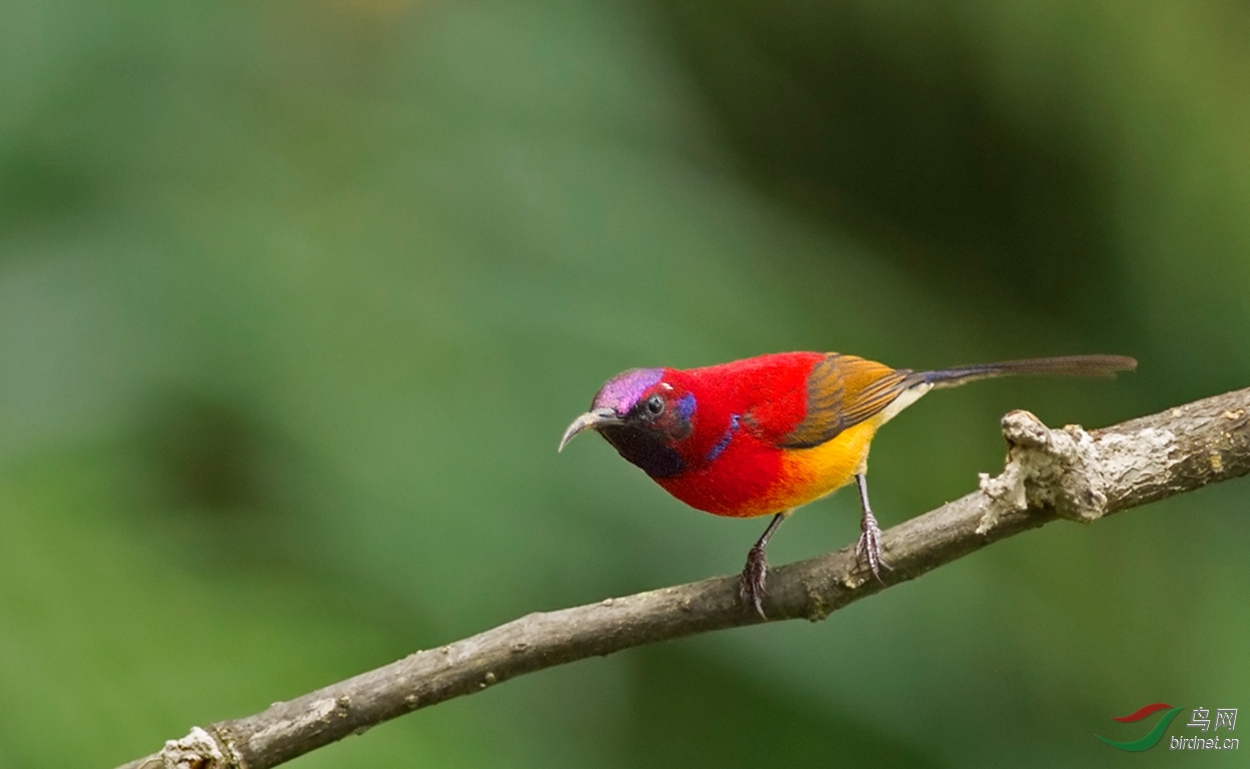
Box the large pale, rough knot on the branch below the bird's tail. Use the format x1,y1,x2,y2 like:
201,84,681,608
976,411,1108,534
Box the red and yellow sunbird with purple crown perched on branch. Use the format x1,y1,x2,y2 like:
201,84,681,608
558,353,1138,616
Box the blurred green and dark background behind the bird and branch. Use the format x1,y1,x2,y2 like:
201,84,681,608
0,0,1250,769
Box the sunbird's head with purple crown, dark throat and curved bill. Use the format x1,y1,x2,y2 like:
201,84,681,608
559,369,696,478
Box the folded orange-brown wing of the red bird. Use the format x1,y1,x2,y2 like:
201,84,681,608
778,353,911,449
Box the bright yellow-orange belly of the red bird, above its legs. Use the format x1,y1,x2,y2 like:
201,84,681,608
766,419,881,513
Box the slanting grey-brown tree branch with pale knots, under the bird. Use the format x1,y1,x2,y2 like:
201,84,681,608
123,389,1250,769
